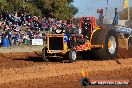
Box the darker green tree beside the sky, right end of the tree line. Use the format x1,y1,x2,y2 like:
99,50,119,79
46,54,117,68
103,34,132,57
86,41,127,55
36,0,78,19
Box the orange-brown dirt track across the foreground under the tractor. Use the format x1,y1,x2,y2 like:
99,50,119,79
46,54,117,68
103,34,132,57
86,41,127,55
0,48,132,88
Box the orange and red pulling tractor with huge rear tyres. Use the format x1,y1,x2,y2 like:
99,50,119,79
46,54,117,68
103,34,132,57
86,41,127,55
42,10,118,62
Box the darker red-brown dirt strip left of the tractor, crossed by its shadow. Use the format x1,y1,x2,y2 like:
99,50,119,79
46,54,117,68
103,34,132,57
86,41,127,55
0,52,41,69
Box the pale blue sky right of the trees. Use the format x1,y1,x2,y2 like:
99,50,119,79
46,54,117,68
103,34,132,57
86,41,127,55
73,0,132,19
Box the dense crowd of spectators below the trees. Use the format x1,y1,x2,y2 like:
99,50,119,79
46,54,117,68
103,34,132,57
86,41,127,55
0,12,78,46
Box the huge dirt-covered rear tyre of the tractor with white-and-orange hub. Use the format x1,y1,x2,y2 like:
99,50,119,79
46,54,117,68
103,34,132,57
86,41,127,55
92,29,118,60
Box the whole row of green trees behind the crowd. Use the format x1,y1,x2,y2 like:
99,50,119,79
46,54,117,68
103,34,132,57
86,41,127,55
0,0,78,19
